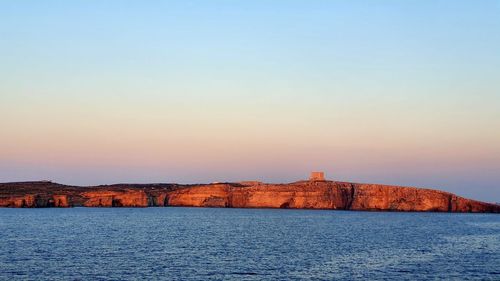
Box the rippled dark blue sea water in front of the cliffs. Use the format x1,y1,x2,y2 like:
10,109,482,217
0,208,500,280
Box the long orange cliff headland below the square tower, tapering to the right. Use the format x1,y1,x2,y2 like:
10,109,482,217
155,181,500,212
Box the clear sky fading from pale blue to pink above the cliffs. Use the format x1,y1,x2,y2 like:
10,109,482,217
0,0,500,202
